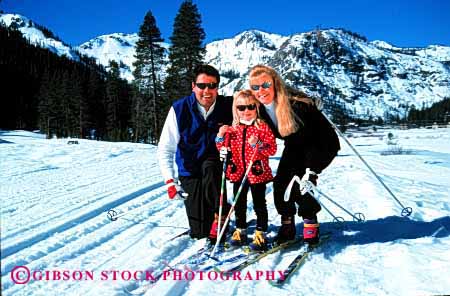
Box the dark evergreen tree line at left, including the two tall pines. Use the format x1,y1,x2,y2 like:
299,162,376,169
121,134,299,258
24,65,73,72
0,0,205,143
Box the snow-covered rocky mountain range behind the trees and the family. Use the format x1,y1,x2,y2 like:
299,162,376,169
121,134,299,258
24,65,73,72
0,15,450,120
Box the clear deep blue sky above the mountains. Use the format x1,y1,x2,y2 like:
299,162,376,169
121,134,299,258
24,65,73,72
0,0,450,47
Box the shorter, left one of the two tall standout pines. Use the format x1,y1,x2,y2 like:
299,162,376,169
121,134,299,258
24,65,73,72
132,11,165,142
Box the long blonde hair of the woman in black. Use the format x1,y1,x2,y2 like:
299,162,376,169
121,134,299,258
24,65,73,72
250,65,298,137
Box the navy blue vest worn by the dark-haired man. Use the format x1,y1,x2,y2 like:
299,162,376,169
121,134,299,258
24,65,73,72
172,93,233,176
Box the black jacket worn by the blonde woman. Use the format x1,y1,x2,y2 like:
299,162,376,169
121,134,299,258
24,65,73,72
259,101,340,173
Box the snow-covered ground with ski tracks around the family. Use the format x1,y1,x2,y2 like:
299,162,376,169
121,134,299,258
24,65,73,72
0,128,450,296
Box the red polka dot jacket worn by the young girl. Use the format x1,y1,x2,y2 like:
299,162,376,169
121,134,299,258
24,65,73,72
216,122,277,184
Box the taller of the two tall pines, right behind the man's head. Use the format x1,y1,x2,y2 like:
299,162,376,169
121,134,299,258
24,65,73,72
164,0,206,101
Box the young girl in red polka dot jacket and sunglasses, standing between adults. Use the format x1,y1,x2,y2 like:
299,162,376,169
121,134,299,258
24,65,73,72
216,90,277,250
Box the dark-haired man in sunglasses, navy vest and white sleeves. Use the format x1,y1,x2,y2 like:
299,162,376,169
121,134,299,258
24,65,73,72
158,65,232,244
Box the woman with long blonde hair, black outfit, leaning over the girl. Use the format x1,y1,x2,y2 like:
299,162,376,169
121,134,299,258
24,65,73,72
250,65,340,243
